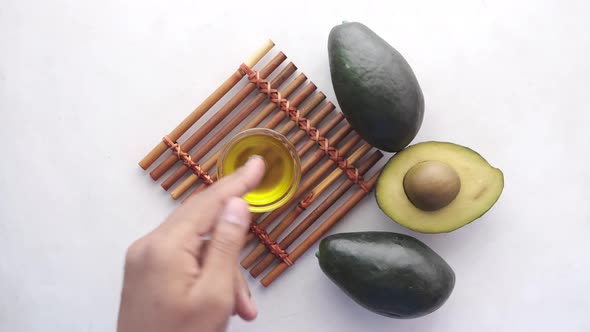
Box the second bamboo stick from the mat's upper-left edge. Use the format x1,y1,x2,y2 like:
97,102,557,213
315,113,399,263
150,52,287,180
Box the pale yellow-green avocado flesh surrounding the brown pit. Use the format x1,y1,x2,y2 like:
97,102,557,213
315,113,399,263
375,142,504,233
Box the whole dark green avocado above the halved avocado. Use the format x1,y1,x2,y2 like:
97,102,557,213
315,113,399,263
328,22,424,152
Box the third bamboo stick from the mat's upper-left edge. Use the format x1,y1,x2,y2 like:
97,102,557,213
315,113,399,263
161,62,297,190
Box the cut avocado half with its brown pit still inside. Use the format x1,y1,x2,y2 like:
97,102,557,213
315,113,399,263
375,142,504,233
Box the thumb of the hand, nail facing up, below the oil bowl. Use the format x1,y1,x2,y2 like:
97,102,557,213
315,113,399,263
203,197,251,285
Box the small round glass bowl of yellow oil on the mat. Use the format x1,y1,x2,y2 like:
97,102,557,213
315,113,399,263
217,128,301,213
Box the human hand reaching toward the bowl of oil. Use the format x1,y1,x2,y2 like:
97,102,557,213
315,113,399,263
117,157,265,332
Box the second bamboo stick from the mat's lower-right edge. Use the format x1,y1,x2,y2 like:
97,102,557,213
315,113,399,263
250,151,383,278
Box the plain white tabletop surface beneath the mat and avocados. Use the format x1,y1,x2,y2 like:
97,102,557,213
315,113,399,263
0,0,590,332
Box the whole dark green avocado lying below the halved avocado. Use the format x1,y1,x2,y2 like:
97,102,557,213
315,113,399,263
318,232,455,318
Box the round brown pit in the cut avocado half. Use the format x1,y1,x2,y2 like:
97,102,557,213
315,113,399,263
403,160,461,211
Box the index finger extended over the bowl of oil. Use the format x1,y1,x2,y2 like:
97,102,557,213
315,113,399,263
164,156,265,236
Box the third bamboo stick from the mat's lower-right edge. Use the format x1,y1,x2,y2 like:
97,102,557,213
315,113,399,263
241,143,371,268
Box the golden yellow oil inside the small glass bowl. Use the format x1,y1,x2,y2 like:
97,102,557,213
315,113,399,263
222,135,297,206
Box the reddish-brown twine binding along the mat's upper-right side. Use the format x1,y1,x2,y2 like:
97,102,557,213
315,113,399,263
240,63,370,193
